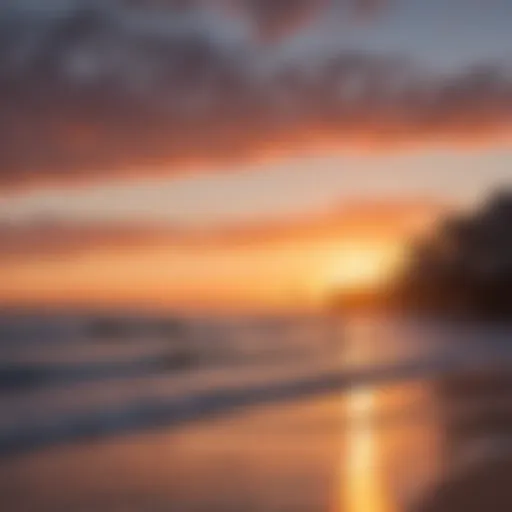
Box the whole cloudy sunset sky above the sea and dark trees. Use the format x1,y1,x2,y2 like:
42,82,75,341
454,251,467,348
0,0,512,311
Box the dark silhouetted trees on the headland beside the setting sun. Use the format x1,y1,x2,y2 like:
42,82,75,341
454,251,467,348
334,190,512,319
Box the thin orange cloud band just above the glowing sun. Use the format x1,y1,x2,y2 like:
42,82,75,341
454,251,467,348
0,198,447,265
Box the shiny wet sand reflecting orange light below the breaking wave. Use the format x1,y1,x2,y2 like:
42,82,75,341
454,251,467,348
0,384,440,512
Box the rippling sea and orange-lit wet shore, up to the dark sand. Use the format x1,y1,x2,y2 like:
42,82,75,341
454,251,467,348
0,317,512,512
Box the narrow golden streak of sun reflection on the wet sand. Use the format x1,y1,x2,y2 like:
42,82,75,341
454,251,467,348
338,388,392,512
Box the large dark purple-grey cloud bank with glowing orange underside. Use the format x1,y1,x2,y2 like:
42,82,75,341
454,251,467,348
0,0,512,190
